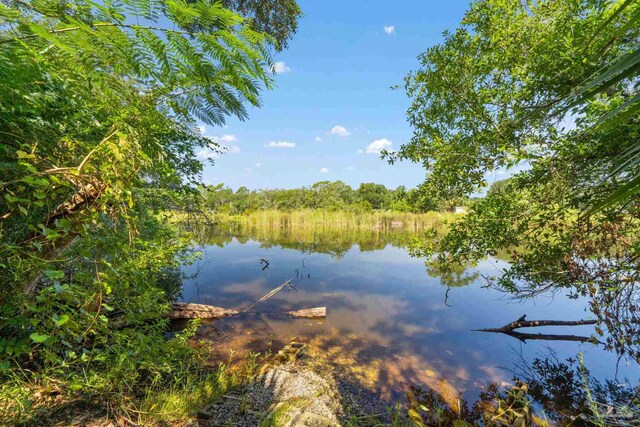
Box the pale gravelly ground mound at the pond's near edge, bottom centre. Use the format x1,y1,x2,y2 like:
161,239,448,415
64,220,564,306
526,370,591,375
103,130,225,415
198,342,387,427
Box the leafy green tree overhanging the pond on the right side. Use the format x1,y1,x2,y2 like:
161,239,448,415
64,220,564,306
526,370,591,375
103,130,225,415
400,0,640,357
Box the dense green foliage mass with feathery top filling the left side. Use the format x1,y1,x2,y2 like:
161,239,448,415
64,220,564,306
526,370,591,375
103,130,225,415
0,0,272,425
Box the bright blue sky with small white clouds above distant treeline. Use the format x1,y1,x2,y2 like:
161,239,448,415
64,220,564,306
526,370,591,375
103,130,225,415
198,0,469,189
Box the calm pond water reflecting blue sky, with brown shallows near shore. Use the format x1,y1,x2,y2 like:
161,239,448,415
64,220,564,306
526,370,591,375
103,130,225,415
182,228,640,420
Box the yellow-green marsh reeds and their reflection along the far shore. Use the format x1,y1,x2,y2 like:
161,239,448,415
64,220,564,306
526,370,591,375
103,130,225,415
180,210,460,257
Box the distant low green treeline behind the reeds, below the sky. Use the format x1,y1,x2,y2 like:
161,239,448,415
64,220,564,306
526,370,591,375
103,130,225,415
200,181,467,214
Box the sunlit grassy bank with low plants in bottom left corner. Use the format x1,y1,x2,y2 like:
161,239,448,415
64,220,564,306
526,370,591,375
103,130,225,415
0,323,262,426
